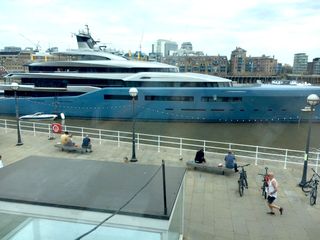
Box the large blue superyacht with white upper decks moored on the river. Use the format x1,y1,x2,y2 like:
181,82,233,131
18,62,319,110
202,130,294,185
0,29,320,122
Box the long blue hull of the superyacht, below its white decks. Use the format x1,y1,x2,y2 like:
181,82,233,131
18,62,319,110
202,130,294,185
0,86,320,122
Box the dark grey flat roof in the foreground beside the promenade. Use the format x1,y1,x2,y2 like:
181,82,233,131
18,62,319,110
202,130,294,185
0,156,185,219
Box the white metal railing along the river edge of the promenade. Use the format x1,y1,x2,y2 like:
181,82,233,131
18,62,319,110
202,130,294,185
0,119,320,170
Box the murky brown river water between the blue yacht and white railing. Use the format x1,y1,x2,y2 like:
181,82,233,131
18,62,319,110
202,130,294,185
60,119,320,150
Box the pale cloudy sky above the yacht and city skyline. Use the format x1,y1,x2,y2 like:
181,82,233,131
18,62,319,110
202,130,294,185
0,0,320,65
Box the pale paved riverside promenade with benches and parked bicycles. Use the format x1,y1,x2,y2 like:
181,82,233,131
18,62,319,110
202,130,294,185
0,128,320,240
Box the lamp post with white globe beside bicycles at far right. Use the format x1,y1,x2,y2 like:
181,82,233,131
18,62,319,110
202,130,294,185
299,94,320,187
